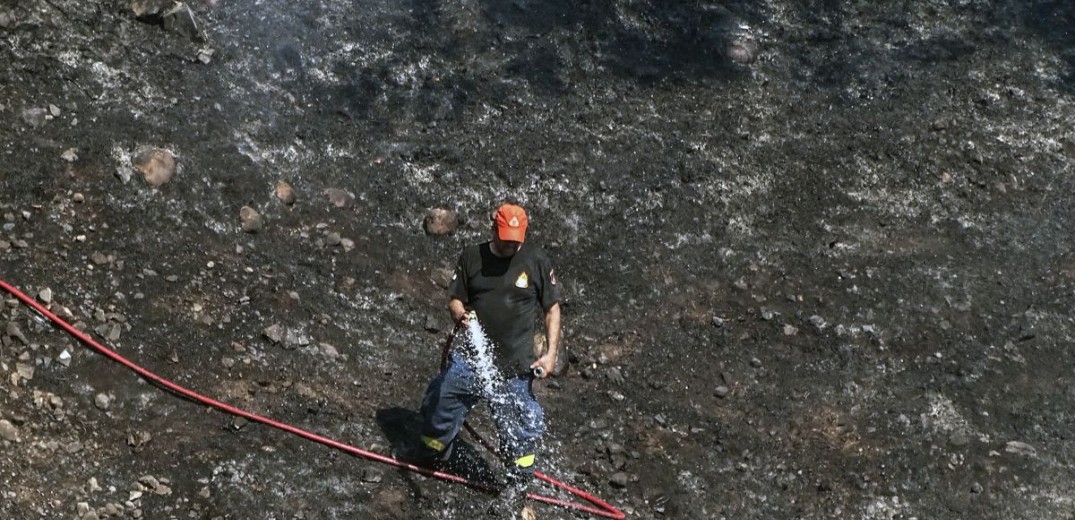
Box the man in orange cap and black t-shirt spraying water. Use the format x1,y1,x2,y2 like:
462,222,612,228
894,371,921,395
410,200,560,483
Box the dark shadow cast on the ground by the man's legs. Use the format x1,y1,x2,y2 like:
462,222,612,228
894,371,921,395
376,406,498,489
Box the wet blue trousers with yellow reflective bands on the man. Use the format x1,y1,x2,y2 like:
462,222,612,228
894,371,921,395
421,352,545,472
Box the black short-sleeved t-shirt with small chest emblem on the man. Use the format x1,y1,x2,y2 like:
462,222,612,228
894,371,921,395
448,242,560,376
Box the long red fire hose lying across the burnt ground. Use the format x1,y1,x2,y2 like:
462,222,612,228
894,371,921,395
0,280,626,520
